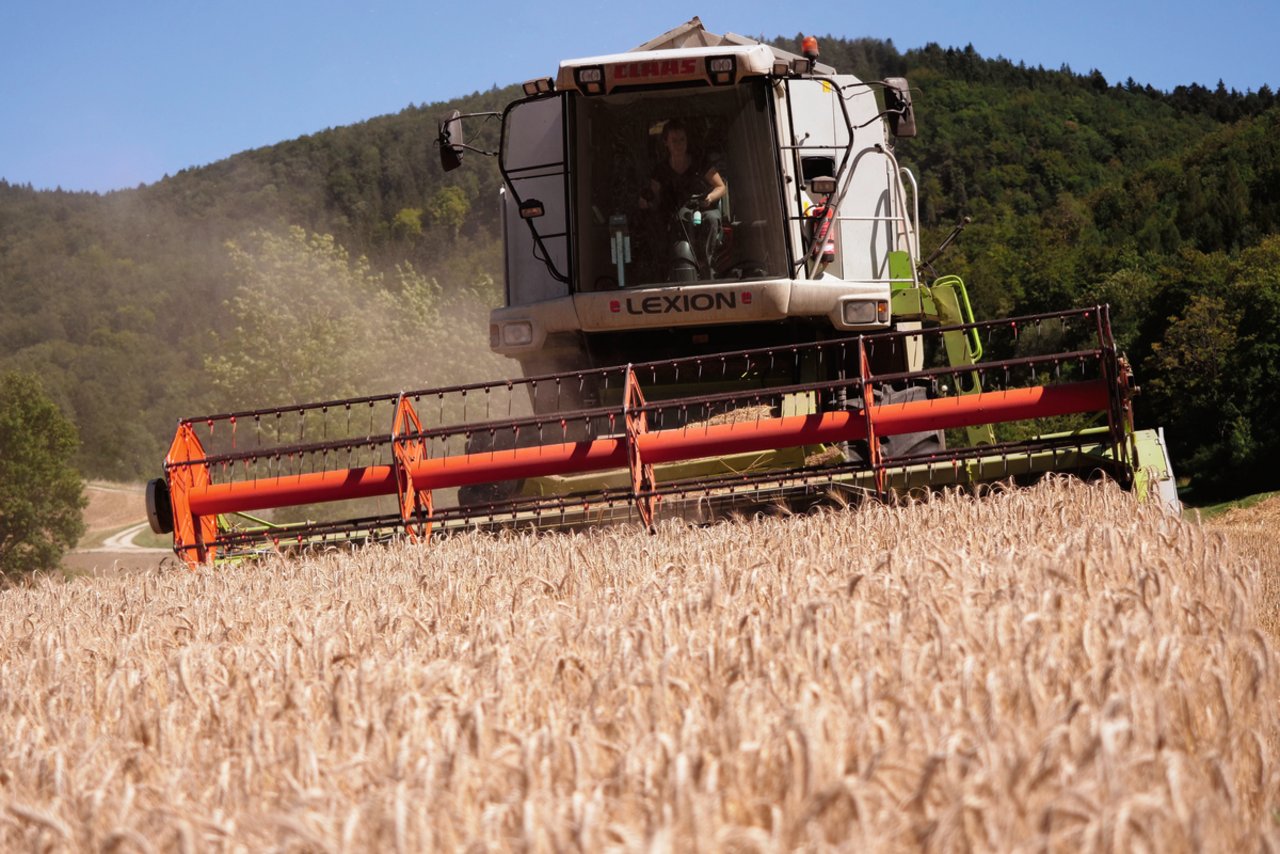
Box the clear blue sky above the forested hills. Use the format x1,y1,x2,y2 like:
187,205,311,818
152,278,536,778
0,0,1280,191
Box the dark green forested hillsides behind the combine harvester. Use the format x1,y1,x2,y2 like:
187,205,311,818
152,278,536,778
0,37,1280,490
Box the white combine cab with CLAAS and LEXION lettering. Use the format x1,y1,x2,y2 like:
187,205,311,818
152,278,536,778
440,19,918,375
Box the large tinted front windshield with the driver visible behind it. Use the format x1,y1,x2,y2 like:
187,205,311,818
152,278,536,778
572,78,787,291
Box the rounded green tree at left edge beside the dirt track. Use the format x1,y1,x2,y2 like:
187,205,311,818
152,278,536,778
0,371,84,575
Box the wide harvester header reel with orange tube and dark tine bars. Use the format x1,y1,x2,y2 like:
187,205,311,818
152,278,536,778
147,306,1157,566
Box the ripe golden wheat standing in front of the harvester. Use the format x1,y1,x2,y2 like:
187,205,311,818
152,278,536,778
0,480,1280,851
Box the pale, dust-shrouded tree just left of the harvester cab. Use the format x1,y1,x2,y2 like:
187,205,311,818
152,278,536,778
206,227,494,408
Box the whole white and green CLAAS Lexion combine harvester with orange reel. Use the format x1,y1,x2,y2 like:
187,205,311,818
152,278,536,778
147,18,1176,566
